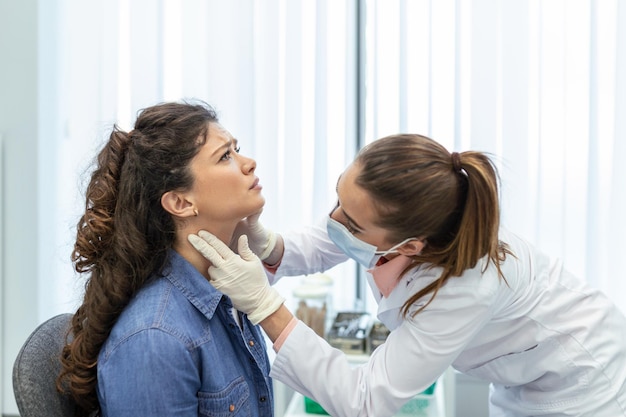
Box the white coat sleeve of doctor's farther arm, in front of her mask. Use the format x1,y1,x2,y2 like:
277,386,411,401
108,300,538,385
268,218,348,283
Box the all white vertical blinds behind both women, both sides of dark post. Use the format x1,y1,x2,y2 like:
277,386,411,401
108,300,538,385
39,0,626,322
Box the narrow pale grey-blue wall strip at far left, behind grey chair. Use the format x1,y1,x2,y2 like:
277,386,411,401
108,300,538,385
0,0,39,414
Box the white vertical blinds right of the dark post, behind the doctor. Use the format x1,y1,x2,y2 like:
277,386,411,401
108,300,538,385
365,0,626,311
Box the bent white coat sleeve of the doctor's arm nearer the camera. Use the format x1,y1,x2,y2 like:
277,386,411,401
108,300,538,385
271,272,491,417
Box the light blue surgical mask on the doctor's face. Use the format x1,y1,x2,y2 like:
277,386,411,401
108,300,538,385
326,216,415,269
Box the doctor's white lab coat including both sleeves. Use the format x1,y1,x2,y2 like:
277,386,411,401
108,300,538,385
271,219,626,417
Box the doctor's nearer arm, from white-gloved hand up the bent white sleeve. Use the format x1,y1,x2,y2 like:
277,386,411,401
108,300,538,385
188,232,485,416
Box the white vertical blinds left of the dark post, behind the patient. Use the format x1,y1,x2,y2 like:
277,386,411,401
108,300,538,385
39,0,357,316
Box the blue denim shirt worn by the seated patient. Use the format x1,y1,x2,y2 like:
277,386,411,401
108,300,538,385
98,251,273,417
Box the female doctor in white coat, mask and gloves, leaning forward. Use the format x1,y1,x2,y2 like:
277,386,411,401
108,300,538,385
189,135,626,417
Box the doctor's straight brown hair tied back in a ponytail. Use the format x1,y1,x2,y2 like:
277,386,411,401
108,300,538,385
355,134,510,315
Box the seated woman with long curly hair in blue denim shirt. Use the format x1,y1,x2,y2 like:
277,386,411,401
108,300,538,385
58,103,273,417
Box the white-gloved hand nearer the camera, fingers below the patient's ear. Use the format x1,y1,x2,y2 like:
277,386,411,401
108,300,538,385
188,230,285,325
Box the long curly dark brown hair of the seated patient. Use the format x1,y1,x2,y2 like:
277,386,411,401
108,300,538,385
57,103,218,416
